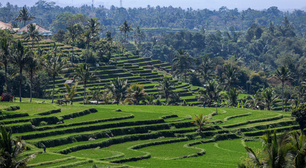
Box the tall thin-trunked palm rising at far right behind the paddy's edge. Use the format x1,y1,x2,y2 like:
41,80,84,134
274,66,291,111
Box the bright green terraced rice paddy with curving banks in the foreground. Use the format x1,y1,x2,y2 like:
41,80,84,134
0,103,298,168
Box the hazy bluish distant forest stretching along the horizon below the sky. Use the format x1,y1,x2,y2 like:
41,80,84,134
0,0,306,35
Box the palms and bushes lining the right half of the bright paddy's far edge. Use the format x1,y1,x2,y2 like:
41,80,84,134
198,64,298,111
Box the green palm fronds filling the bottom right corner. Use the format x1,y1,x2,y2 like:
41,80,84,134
238,129,306,168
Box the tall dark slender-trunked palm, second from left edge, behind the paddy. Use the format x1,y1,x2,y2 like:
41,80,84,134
11,40,34,102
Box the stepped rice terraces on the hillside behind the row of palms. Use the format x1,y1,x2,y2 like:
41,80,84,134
20,40,203,105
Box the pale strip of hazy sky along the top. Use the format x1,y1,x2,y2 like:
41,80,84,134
0,0,306,10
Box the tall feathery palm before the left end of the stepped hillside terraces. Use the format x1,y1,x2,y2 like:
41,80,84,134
42,53,67,103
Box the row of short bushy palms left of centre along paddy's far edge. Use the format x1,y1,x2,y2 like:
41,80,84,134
75,76,179,105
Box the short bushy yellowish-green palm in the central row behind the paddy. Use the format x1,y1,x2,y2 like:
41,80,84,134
126,83,147,105
